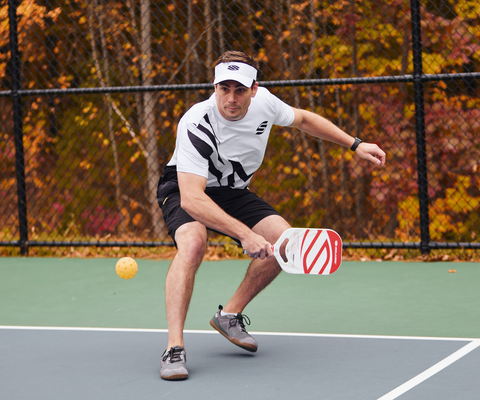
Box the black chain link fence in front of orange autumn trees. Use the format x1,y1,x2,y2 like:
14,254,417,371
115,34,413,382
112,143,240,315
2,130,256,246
0,0,480,253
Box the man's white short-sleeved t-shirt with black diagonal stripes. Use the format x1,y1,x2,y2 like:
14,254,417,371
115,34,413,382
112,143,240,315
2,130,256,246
168,87,294,189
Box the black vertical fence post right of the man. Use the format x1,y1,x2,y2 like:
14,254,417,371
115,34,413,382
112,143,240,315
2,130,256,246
410,0,430,254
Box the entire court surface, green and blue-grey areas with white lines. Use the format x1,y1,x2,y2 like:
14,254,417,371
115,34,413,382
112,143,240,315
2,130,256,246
0,258,480,400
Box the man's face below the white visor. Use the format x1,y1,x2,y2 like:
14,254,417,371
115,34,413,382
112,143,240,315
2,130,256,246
215,81,258,121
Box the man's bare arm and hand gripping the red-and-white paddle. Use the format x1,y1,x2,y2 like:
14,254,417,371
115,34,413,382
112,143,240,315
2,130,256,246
177,172,272,260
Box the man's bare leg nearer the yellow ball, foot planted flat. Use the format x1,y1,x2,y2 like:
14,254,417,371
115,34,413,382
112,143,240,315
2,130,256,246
165,222,207,349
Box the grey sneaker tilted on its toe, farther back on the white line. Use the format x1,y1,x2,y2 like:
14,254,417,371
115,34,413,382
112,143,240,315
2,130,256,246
210,306,258,353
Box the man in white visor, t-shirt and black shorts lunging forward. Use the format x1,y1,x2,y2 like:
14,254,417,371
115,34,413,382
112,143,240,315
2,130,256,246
157,51,385,380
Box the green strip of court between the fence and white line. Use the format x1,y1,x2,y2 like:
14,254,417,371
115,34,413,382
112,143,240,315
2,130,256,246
0,257,480,338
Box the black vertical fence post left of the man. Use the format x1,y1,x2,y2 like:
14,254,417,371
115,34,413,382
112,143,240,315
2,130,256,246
8,0,28,255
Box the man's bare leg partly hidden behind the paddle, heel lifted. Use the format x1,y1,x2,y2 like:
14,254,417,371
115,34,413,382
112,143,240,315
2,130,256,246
224,215,290,313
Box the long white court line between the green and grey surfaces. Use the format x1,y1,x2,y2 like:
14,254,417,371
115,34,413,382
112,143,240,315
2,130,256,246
0,325,480,342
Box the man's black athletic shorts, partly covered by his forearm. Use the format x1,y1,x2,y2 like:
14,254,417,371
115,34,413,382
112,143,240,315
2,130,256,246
157,167,280,241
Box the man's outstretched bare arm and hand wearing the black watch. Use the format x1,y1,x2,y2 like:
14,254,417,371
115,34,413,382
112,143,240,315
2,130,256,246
290,108,386,165
